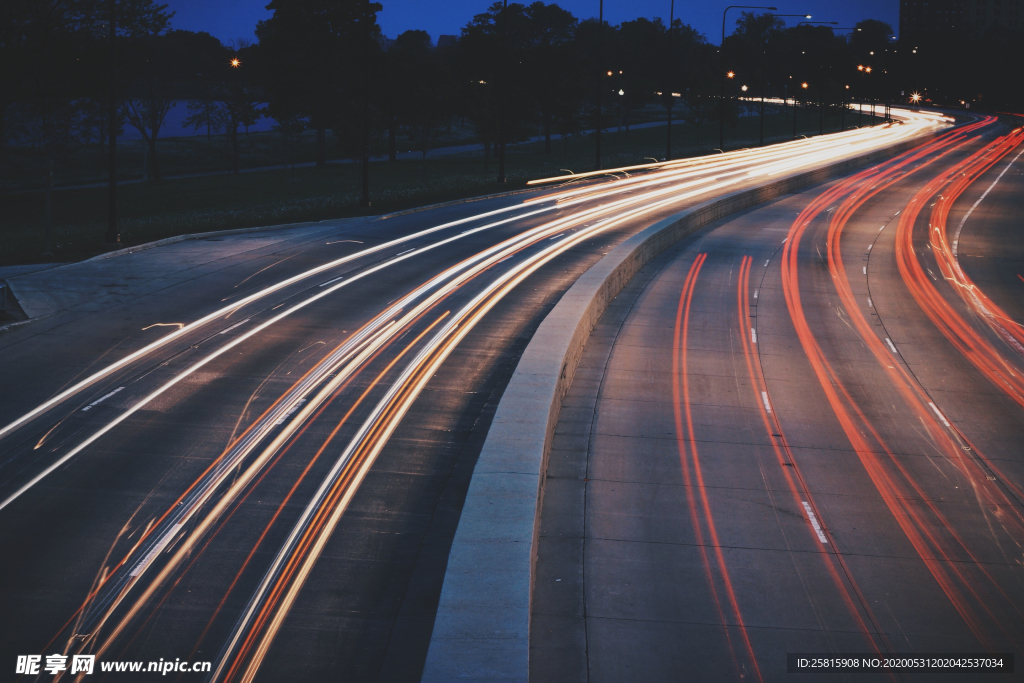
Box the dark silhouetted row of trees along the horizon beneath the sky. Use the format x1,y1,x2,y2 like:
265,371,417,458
0,0,1021,184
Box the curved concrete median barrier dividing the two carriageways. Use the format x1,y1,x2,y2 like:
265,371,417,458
421,133,937,683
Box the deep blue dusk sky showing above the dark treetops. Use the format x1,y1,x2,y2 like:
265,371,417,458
164,0,899,43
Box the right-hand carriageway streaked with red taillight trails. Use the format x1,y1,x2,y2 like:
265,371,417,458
530,112,1024,682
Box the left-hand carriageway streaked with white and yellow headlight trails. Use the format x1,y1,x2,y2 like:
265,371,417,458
0,113,948,681
